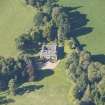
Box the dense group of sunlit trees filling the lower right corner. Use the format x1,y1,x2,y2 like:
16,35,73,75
66,51,105,105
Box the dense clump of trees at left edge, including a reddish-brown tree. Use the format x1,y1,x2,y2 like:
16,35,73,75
0,55,35,94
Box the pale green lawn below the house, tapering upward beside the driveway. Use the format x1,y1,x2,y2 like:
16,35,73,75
0,60,70,105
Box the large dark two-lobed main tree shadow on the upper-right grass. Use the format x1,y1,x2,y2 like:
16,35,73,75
69,11,93,37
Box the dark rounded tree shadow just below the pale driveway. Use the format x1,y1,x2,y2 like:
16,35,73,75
35,70,54,81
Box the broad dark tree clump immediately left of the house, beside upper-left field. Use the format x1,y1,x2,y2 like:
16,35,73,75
16,32,42,53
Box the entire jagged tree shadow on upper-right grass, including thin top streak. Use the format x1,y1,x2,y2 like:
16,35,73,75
63,6,93,50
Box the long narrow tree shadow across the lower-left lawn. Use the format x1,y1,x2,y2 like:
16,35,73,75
16,85,44,95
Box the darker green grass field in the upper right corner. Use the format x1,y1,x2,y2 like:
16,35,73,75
60,0,105,54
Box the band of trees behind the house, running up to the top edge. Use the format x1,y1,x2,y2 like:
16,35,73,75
16,0,70,52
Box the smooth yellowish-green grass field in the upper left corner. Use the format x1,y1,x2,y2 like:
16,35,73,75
0,0,35,56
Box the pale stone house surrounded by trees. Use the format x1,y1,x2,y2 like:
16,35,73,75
40,43,63,62
